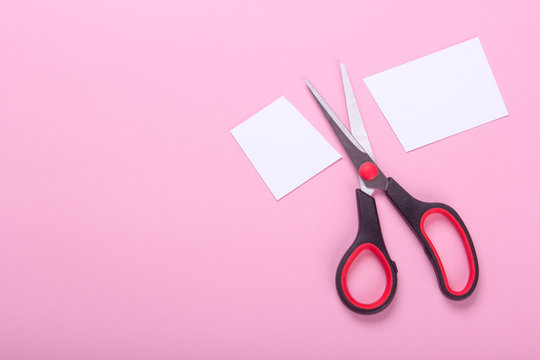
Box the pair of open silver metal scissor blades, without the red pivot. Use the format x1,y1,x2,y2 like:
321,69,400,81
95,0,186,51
306,64,387,195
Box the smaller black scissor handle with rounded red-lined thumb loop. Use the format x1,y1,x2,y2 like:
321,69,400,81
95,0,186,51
336,189,397,314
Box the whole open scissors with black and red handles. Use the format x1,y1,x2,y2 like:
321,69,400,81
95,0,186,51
306,64,479,314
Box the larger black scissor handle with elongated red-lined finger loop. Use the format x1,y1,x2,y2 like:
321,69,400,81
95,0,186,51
386,178,479,300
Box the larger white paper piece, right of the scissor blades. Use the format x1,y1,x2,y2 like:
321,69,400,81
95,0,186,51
364,38,508,151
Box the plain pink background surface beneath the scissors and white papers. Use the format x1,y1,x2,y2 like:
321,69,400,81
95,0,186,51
0,0,540,359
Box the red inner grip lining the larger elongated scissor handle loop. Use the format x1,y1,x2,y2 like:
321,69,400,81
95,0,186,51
420,208,476,296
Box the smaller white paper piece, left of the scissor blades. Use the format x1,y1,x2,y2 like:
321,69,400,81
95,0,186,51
231,96,341,200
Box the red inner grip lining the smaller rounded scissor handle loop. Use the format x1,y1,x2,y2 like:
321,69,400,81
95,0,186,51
341,243,393,310
